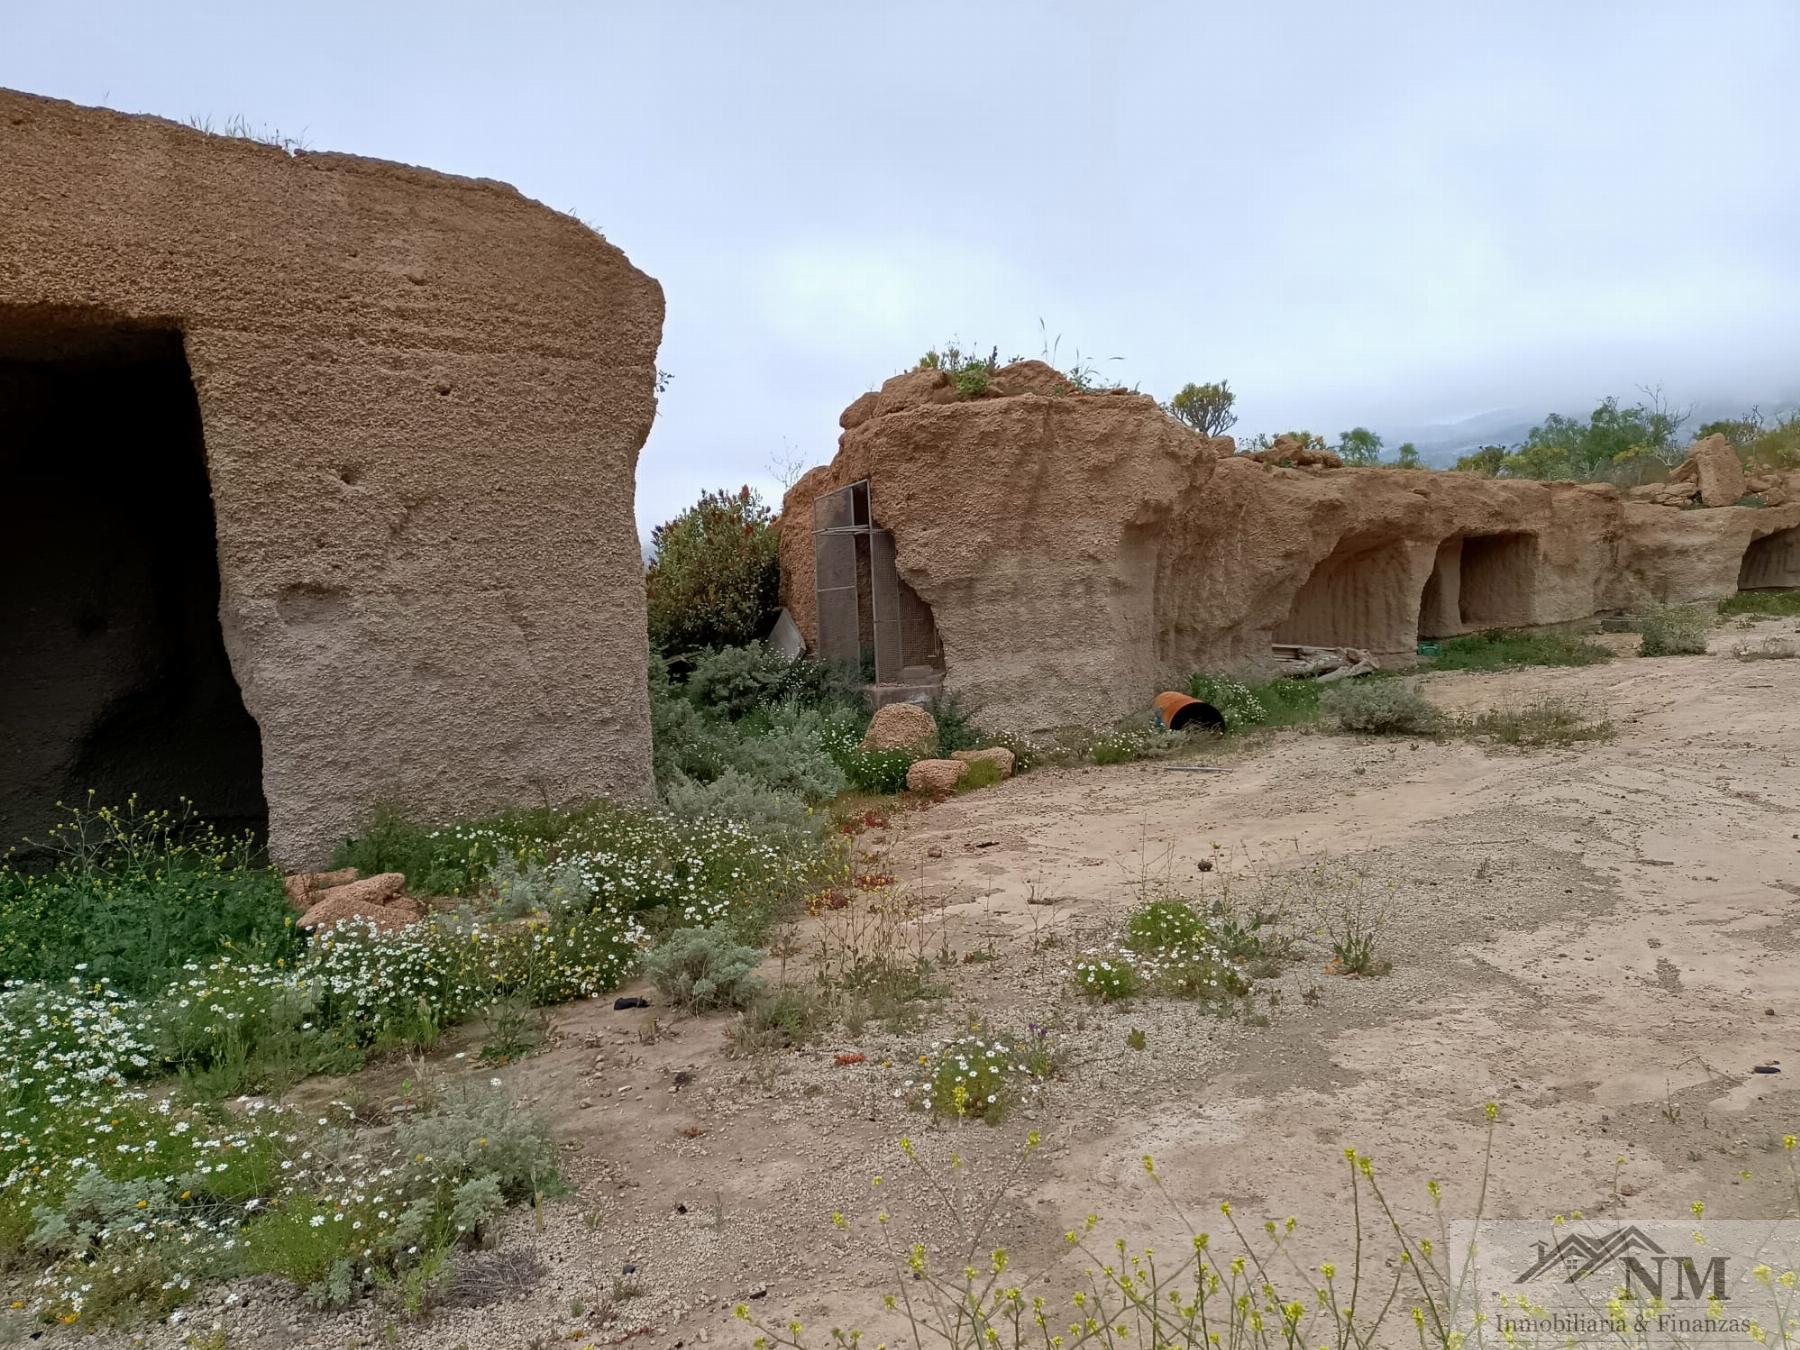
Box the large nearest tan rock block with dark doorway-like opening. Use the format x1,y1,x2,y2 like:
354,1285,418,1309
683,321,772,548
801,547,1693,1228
0,92,662,866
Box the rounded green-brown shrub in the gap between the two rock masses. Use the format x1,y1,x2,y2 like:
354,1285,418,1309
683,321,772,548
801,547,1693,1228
644,488,781,652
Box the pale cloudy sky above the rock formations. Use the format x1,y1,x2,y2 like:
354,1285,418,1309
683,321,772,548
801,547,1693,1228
0,0,1800,536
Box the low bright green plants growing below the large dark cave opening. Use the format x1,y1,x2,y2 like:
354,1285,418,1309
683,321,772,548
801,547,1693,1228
0,797,299,994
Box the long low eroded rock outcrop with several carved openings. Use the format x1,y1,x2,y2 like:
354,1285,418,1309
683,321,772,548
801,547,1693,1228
781,369,1800,733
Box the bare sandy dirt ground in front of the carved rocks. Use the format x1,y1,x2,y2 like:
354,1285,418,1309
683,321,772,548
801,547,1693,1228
133,623,1800,1350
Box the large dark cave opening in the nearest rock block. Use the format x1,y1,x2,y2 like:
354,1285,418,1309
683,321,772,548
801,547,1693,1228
0,310,268,839
